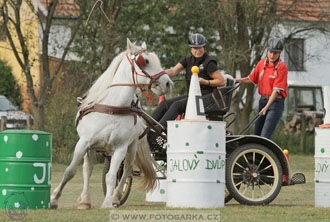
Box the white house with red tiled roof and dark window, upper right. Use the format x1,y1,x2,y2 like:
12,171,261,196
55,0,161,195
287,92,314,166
274,0,330,85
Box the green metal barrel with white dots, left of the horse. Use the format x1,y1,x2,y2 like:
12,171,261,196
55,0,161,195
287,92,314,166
0,130,52,210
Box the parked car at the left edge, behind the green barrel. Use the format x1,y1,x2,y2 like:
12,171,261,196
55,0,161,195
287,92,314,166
0,95,33,129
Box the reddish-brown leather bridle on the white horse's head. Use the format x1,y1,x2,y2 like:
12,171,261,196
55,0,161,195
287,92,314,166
108,48,165,101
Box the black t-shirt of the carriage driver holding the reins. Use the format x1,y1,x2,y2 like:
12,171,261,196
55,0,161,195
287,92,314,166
180,53,219,95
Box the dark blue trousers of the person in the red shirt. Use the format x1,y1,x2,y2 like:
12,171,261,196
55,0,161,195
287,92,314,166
254,98,284,139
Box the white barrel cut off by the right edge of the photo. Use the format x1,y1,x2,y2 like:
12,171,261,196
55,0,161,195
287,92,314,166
314,128,330,207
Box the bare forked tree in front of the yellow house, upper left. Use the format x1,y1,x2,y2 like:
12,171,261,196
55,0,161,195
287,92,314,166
0,0,83,130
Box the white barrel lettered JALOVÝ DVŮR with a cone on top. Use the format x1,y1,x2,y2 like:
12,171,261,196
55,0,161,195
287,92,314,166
166,121,226,208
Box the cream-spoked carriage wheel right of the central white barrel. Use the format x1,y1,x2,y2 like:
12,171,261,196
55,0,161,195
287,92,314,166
226,143,282,205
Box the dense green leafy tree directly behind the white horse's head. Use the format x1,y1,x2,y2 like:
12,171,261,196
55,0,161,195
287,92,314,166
70,0,216,100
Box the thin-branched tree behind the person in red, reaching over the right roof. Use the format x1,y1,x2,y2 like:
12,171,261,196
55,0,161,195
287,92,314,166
197,0,329,132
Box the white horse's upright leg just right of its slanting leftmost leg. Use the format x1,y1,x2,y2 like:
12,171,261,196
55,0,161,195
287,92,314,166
78,150,94,210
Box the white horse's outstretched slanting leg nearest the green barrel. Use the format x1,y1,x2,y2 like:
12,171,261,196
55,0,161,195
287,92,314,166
50,139,88,209
